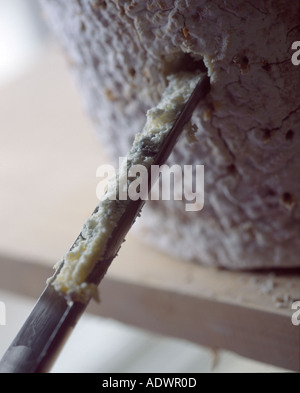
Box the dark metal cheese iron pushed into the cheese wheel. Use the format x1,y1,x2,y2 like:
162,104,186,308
0,76,210,373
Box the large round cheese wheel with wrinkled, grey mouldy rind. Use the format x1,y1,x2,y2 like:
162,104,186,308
42,0,300,269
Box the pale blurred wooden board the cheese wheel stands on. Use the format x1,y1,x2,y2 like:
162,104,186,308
0,47,300,371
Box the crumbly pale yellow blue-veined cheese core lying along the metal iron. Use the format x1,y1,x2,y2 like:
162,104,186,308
52,73,200,302
